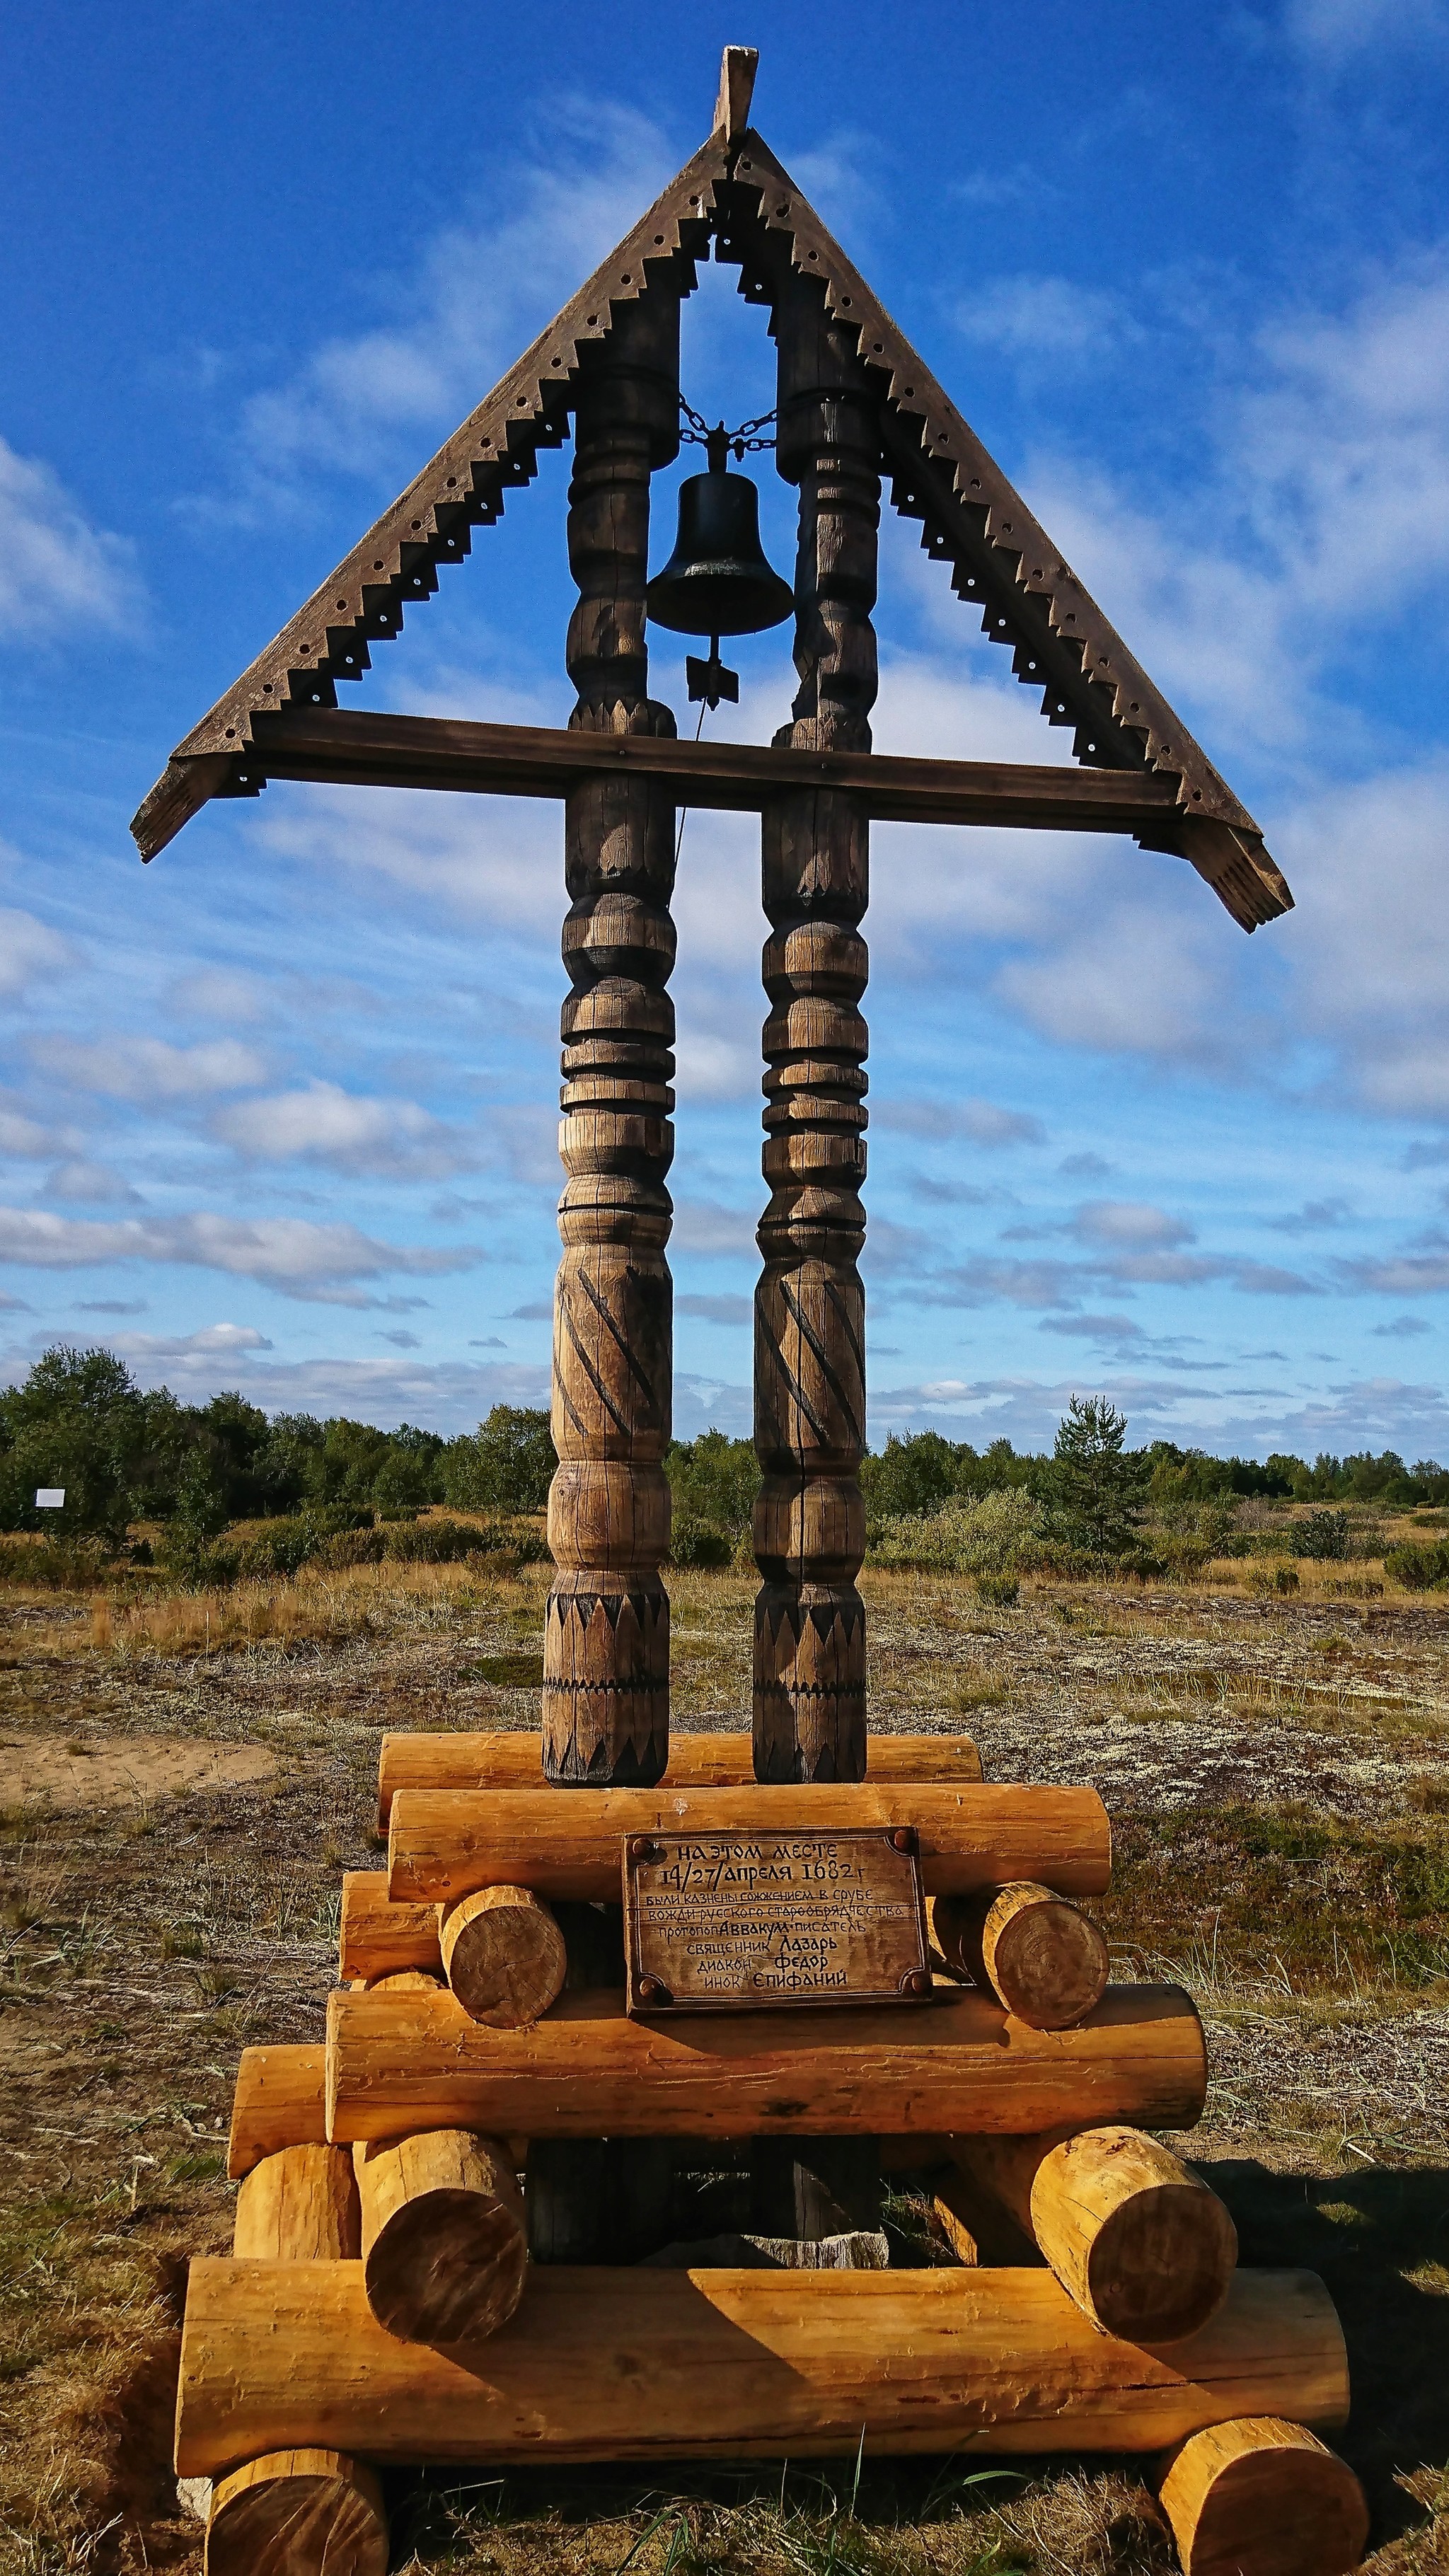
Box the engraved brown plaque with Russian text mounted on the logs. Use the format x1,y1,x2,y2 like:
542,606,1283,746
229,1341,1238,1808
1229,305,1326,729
624,1826,931,2012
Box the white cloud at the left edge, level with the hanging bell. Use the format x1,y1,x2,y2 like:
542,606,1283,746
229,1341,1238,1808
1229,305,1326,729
0,438,142,644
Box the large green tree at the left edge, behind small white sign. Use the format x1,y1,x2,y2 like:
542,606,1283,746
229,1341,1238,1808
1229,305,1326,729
0,1342,147,1540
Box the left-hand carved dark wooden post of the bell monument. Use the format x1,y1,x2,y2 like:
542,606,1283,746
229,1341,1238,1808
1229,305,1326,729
544,286,678,1788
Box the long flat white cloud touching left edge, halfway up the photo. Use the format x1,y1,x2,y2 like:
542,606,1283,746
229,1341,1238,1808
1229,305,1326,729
0,1208,477,1306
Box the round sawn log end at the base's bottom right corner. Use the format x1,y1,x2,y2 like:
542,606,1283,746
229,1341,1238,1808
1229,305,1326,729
1163,2416,1369,2576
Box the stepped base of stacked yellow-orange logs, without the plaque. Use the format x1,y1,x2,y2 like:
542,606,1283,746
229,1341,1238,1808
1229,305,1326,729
175,1736,1366,2576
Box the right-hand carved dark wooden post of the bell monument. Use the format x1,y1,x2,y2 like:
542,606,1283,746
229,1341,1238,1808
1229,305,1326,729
756,273,879,1780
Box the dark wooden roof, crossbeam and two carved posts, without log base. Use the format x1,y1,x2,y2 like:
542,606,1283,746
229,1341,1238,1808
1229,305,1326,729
132,47,1292,1788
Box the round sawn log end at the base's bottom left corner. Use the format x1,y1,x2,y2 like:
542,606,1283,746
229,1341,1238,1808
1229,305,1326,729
207,2450,387,2576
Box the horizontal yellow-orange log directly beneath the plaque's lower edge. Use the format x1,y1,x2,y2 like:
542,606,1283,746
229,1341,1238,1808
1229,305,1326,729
328,1978,1206,2141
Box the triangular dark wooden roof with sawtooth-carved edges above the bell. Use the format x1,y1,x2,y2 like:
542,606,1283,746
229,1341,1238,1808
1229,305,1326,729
132,47,1292,930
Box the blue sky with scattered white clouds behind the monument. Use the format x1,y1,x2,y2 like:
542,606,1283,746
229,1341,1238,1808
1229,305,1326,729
0,0,1449,1458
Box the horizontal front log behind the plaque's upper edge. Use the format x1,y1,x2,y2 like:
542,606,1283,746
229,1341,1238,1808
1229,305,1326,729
387,1783,1112,1904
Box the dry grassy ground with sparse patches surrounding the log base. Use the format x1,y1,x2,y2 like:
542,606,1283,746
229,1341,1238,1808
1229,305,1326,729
0,1566,1449,2576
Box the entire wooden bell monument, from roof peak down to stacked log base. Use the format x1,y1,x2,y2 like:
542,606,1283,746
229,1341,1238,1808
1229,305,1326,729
132,47,1366,2576
